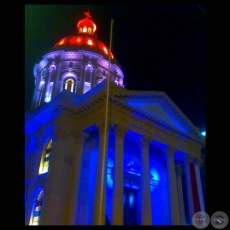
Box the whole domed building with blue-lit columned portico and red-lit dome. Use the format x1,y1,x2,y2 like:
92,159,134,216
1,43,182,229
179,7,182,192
25,12,205,225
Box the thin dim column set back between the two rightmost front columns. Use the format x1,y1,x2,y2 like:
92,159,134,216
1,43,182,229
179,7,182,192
176,165,186,225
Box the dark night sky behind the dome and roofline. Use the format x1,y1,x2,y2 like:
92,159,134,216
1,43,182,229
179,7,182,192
25,4,206,130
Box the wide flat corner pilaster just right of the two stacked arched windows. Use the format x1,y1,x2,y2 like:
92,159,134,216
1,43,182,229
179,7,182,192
40,124,74,225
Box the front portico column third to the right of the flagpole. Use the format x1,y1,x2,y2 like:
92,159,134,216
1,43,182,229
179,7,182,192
164,147,180,225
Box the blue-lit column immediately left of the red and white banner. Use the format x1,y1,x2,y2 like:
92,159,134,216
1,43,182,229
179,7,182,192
183,154,194,225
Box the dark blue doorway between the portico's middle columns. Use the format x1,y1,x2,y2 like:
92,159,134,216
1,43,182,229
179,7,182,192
123,188,138,225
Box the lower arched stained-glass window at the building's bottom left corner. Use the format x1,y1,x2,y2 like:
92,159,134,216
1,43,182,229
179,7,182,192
30,189,44,225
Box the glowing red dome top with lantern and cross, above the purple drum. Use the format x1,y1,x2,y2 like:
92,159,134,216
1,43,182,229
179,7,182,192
52,12,114,61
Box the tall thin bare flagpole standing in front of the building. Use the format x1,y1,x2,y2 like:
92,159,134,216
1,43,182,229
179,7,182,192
99,19,114,225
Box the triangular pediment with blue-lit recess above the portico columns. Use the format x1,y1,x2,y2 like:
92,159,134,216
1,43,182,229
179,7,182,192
108,84,200,136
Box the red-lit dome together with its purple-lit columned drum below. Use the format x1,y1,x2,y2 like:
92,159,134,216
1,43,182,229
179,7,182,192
31,12,124,109
